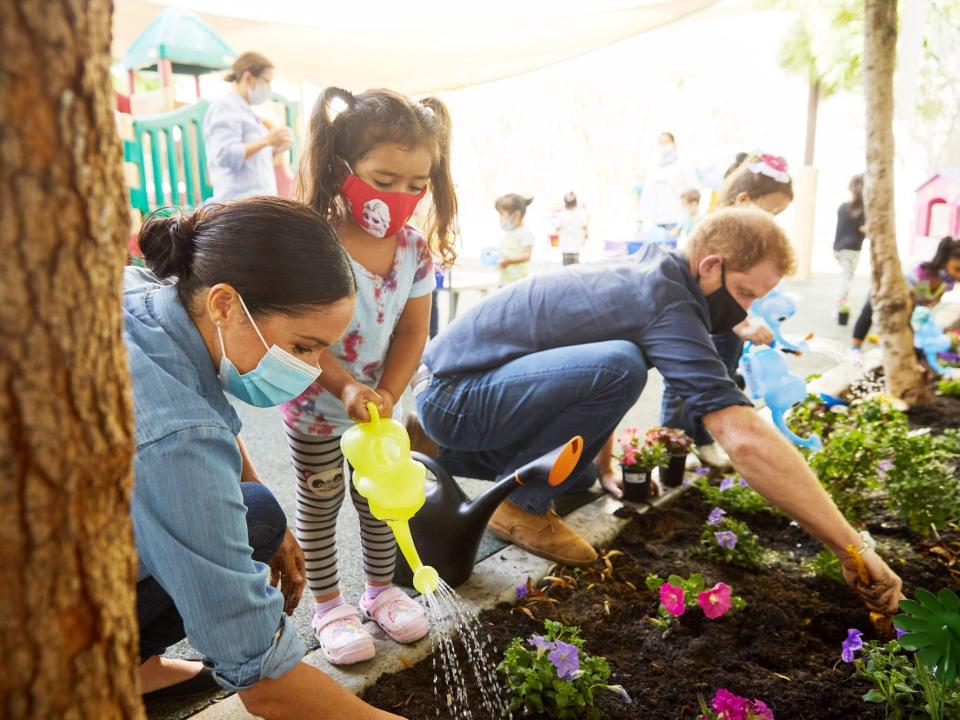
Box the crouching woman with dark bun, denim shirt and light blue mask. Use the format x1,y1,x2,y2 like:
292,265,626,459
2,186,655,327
123,198,397,720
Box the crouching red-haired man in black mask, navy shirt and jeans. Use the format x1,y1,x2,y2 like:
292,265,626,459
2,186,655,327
413,208,902,612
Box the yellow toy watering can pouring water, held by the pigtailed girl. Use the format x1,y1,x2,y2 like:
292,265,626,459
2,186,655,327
340,402,440,594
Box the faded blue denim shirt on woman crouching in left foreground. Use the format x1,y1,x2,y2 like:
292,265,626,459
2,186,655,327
123,268,305,690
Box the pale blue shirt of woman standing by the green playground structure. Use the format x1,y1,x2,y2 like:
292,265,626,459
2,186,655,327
203,92,277,201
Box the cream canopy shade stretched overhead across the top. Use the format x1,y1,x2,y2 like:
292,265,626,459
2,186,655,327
113,0,717,95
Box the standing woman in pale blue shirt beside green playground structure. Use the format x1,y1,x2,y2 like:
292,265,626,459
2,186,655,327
203,52,293,201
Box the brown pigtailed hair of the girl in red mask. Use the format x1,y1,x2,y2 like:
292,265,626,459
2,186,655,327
297,87,460,267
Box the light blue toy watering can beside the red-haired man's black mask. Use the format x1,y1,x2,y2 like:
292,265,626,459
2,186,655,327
740,288,823,452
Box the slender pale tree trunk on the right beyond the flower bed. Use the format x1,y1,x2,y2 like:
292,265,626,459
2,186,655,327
863,0,929,405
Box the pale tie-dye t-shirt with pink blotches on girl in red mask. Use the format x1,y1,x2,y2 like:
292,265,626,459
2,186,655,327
280,225,436,436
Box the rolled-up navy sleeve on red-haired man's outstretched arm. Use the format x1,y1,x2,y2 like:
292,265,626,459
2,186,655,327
638,300,753,420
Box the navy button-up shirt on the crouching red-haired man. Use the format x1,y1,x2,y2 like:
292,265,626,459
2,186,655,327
423,243,752,418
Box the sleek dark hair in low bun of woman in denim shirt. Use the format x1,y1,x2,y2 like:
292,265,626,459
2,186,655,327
140,197,356,315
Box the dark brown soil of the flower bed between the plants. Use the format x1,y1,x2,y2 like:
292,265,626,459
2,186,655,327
364,398,960,720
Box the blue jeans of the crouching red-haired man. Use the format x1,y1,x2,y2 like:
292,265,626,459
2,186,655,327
417,340,647,515
